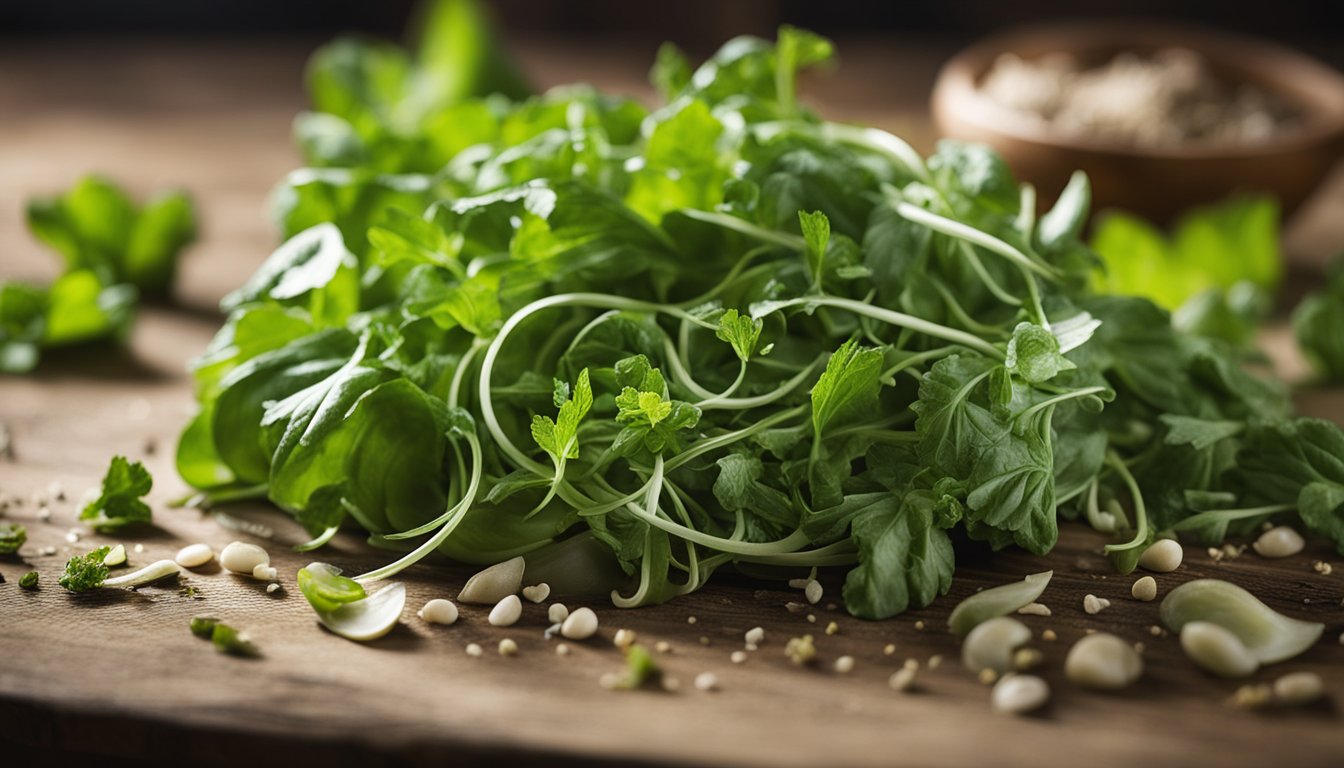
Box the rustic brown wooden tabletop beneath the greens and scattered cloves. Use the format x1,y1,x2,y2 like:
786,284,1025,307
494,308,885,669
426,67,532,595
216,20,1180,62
0,35,1344,767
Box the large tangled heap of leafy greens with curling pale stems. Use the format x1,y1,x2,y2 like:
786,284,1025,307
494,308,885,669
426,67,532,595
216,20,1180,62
177,1,1344,617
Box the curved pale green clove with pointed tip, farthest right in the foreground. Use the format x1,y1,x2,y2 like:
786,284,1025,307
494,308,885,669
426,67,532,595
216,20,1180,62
1160,578,1325,664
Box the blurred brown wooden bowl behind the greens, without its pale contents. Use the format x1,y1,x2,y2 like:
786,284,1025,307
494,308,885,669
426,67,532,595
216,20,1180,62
933,22,1344,222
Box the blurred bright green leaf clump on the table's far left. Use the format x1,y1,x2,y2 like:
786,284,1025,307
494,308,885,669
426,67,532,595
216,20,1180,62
0,176,196,373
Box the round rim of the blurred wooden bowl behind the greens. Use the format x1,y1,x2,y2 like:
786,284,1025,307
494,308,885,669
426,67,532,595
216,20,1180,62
933,19,1344,160
